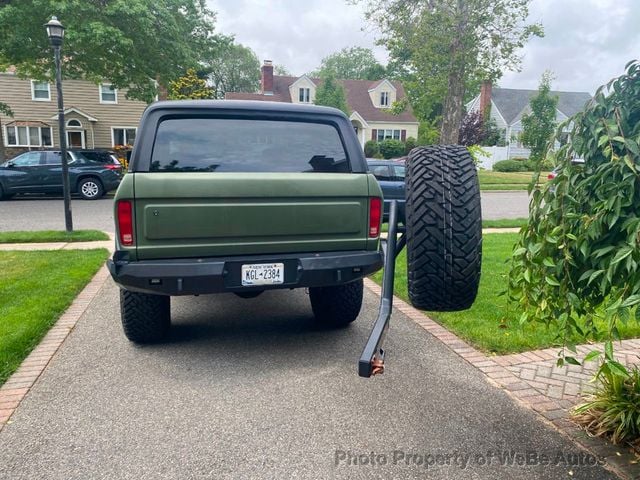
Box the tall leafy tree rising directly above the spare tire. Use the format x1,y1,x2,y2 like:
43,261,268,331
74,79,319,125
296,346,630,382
358,0,542,143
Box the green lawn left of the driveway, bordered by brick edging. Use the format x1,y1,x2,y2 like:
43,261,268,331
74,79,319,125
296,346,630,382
0,249,108,385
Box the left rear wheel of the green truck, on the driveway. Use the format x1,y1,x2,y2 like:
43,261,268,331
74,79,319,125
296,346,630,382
120,289,171,343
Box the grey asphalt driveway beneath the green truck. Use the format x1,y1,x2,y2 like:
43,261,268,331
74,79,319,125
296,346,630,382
0,280,615,480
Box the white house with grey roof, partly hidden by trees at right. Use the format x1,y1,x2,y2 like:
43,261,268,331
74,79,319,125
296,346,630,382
466,82,591,158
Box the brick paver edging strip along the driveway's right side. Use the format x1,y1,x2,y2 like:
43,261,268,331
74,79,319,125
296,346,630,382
364,278,640,479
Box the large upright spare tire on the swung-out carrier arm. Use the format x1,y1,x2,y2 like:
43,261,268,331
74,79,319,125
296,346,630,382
405,145,482,312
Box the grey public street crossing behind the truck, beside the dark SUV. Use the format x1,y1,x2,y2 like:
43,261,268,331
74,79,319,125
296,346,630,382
0,192,529,233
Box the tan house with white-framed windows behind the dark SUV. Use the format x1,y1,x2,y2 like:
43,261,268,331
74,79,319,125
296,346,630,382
0,72,147,158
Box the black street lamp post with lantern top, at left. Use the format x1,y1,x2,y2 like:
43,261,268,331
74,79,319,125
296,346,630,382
45,17,73,232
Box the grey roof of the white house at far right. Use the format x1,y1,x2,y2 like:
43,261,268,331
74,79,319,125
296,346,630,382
491,87,591,125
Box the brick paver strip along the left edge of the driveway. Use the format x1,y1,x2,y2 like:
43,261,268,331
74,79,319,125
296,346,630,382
0,265,109,432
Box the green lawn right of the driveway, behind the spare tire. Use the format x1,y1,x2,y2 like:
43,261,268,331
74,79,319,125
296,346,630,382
373,233,640,355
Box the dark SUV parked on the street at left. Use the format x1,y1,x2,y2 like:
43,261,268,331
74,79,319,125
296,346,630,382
0,150,122,200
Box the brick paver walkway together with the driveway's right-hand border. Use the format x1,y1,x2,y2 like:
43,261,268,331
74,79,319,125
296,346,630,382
365,278,640,479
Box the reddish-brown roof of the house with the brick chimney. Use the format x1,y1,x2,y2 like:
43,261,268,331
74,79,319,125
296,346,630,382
225,75,418,123
